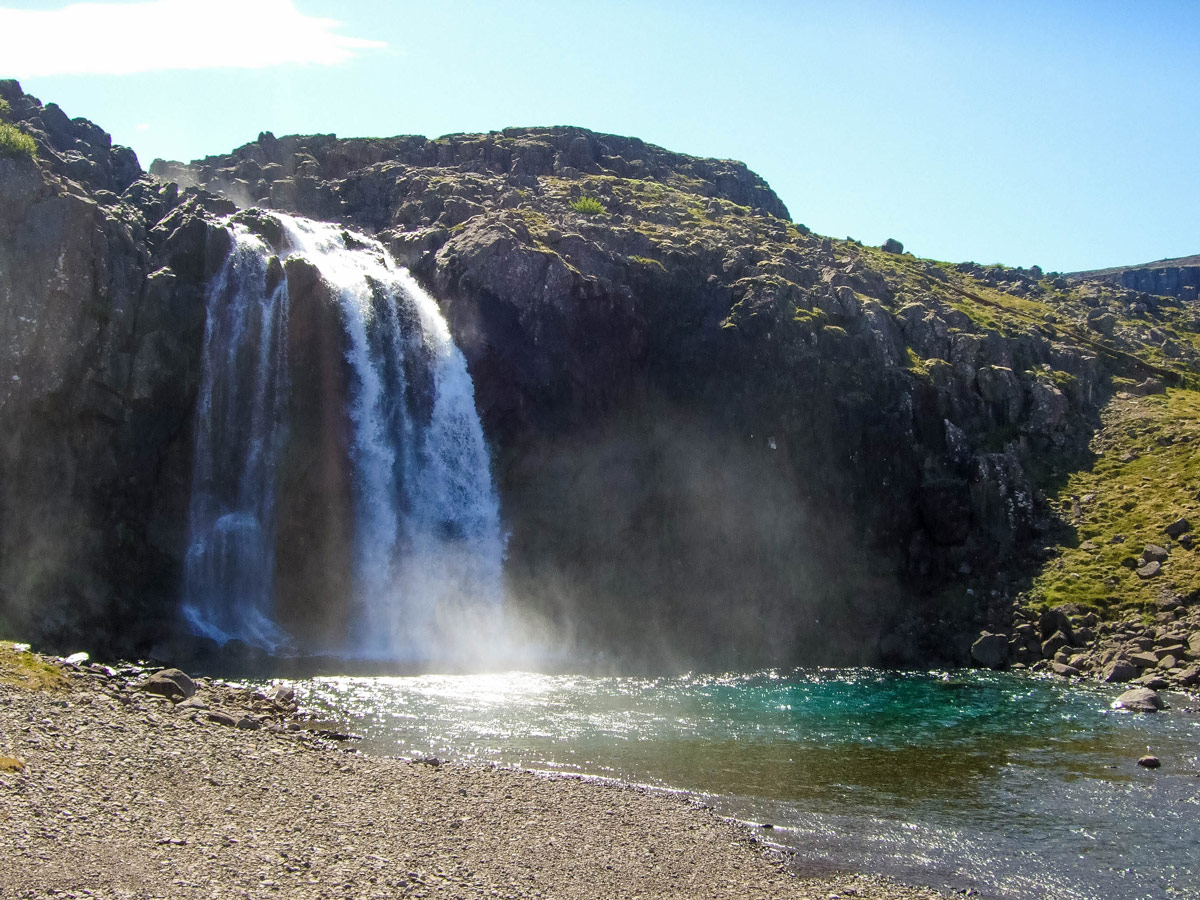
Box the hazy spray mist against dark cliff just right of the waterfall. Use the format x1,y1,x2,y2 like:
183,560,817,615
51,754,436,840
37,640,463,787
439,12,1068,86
502,402,898,671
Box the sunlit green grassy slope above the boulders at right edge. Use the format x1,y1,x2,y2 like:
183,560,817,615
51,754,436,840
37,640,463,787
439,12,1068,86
1030,390,1200,612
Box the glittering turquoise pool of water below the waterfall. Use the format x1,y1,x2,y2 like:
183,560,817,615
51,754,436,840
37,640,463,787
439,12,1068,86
301,670,1200,900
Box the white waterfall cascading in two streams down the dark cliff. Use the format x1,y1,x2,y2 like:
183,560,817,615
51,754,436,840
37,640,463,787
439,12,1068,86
184,214,503,660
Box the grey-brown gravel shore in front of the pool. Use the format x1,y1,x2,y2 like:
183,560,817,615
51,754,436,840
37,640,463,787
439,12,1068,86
0,666,942,900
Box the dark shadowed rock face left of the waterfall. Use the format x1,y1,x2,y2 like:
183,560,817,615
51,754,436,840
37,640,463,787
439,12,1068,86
0,82,228,652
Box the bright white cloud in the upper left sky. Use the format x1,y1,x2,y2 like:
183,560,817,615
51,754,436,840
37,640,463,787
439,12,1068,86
0,0,386,78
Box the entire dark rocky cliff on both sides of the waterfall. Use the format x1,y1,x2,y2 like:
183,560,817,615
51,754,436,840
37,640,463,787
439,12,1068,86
0,83,1195,666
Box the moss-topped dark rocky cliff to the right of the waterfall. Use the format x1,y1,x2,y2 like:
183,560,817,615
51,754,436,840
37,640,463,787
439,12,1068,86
154,128,1176,664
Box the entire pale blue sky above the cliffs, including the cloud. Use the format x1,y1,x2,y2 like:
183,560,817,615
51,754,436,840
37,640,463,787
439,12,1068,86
0,0,1200,271
